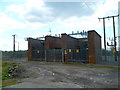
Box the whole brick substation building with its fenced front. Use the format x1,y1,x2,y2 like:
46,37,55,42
27,30,102,64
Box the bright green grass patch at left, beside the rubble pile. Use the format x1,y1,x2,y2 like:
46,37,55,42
0,62,20,87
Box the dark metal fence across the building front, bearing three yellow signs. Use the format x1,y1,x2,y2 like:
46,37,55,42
32,49,88,62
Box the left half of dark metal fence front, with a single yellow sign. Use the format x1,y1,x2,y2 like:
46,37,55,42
32,49,62,62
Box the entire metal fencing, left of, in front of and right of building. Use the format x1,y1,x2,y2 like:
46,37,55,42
0,48,120,65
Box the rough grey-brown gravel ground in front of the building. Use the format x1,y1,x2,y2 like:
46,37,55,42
5,60,118,88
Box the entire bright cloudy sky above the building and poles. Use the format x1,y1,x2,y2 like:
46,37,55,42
0,0,118,50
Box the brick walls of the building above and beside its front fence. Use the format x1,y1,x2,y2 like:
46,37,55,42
28,30,101,64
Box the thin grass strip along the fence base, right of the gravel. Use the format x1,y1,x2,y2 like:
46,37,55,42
64,62,120,69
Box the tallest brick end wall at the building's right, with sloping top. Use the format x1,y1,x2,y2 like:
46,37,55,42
88,30,102,64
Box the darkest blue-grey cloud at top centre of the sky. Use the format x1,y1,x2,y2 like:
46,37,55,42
46,2,94,18
